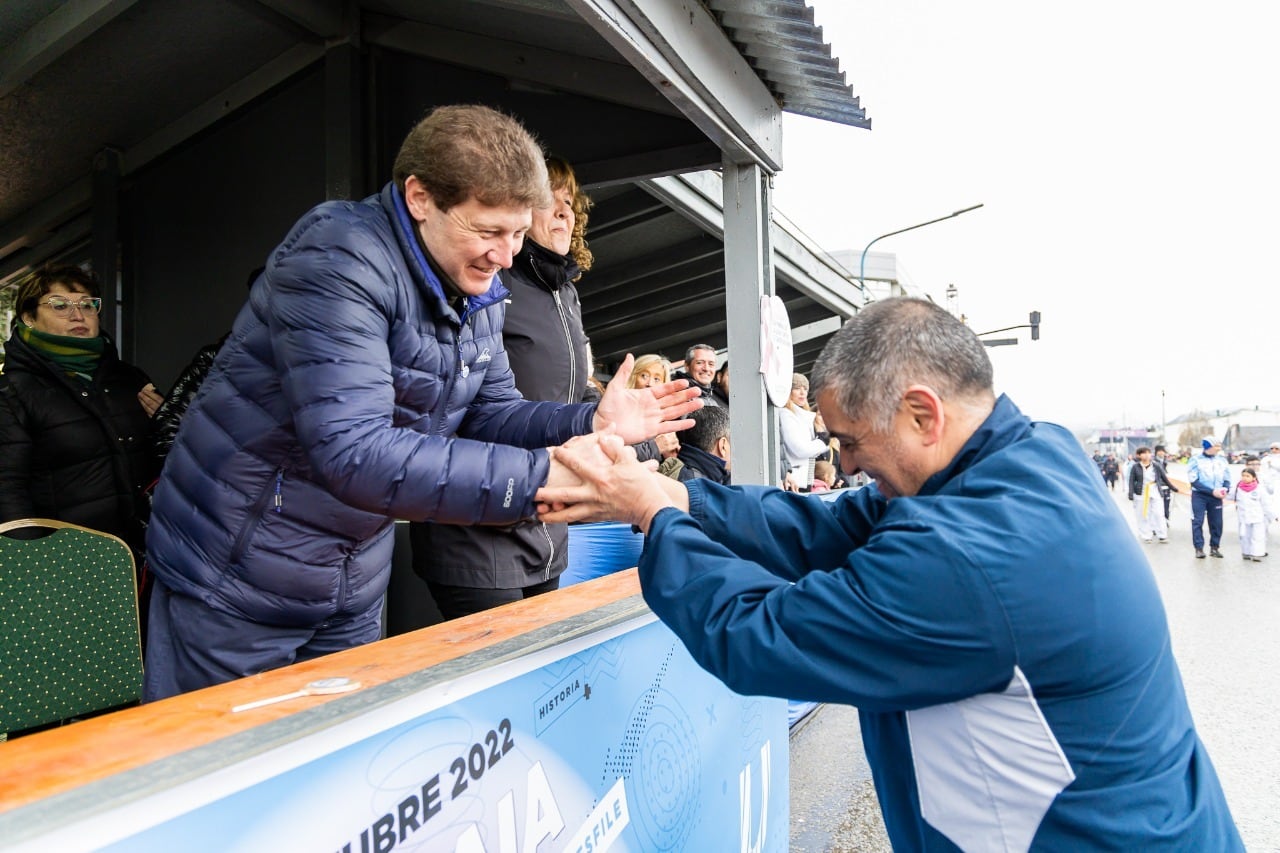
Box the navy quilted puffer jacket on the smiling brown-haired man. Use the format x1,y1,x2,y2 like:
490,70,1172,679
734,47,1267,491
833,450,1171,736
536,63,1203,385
147,184,595,626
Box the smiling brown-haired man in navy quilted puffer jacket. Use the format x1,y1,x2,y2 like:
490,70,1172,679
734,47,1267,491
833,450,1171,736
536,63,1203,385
145,106,698,701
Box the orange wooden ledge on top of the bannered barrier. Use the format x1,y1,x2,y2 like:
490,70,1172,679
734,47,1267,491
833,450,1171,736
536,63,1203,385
0,569,648,809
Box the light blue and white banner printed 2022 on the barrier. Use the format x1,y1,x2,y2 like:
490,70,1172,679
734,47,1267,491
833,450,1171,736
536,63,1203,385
77,621,788,853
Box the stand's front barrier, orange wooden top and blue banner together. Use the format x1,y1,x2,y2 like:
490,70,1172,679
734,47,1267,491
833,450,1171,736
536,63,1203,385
0,569,788,853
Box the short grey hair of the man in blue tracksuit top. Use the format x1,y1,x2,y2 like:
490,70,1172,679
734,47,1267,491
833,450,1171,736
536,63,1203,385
810,298,993,433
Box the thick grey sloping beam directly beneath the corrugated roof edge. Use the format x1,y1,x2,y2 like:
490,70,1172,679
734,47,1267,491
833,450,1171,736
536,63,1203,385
566,0,782,173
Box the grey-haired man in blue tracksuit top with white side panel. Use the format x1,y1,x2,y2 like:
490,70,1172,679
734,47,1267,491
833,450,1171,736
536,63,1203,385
538,300,1243,850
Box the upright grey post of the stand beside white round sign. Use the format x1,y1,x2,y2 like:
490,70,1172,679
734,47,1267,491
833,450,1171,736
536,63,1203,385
723,158,782,485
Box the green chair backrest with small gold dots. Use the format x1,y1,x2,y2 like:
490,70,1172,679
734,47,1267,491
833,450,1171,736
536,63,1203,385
0,519,142,731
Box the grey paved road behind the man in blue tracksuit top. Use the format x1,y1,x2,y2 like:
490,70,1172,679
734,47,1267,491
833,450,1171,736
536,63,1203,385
791,479,1280,853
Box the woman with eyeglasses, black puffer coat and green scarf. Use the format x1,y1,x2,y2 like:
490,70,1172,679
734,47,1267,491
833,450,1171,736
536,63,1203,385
0,266,163,558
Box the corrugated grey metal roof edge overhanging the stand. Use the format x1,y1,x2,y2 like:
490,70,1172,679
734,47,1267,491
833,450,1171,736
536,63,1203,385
703,0,872,129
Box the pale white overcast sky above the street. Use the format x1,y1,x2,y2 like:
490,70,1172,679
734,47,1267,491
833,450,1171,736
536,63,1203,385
774,0,1280,427
